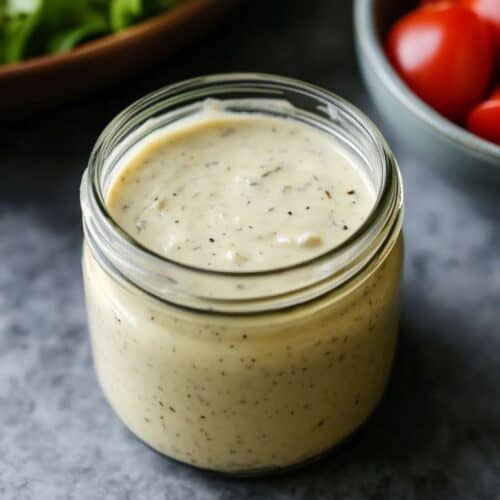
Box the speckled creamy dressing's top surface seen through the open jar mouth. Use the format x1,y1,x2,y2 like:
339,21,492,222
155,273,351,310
107,112,375,271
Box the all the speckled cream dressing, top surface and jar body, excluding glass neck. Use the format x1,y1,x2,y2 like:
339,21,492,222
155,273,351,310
83,104,402,473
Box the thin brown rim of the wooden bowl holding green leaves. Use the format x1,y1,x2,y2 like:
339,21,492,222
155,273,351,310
0,0,230,77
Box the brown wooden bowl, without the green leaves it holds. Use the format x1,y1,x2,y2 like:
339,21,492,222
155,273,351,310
0,0,237,121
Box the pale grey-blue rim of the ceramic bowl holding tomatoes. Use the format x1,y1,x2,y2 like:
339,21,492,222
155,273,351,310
354,0,500,163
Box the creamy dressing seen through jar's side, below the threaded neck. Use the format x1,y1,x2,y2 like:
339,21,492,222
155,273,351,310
84,240,402,472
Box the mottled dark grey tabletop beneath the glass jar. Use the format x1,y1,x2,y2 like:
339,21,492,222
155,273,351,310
0,0,500,500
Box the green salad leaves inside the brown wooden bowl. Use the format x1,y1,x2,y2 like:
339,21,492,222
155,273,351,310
0,0,187,64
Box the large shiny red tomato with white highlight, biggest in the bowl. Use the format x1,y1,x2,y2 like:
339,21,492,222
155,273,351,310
386,3,493,121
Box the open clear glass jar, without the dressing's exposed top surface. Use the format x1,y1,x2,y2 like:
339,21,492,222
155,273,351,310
81,74,403,474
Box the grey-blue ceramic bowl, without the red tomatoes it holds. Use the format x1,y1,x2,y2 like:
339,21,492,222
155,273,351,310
354,0,500,183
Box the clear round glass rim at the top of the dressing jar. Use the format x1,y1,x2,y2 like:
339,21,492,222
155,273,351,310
81,73,403,310
